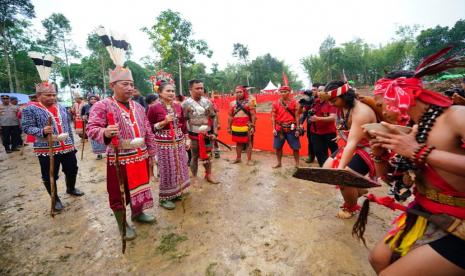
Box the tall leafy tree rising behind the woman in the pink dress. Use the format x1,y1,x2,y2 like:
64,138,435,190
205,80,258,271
142,9,213,94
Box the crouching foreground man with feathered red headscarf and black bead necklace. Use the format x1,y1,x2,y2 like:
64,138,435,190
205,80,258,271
354,48,465,275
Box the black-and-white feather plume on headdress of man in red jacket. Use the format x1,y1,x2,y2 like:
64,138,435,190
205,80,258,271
95,26,129,67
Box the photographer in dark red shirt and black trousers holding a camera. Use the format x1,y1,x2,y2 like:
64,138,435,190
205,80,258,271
300,83,338,167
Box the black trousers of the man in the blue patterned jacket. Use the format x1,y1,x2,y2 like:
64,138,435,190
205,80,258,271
38,151,78,191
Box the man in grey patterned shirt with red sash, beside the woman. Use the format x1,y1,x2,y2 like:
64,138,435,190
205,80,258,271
182,79,219,184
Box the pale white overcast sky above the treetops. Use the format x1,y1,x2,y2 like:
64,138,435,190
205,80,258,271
32,0,465,87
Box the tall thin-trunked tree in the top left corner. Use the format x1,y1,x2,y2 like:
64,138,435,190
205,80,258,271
0,0,35,91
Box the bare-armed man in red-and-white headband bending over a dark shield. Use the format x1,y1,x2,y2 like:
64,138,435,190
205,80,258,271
319,81,377,219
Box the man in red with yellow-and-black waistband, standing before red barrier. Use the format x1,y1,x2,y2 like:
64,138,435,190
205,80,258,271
228,85,257,165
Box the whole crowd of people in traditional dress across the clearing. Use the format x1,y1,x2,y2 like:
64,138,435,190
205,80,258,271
0,43,465,275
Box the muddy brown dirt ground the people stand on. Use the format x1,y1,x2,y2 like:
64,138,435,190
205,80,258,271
0,140,394,275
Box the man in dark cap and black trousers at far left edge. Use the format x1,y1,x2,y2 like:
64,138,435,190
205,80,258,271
0,95,20,153
